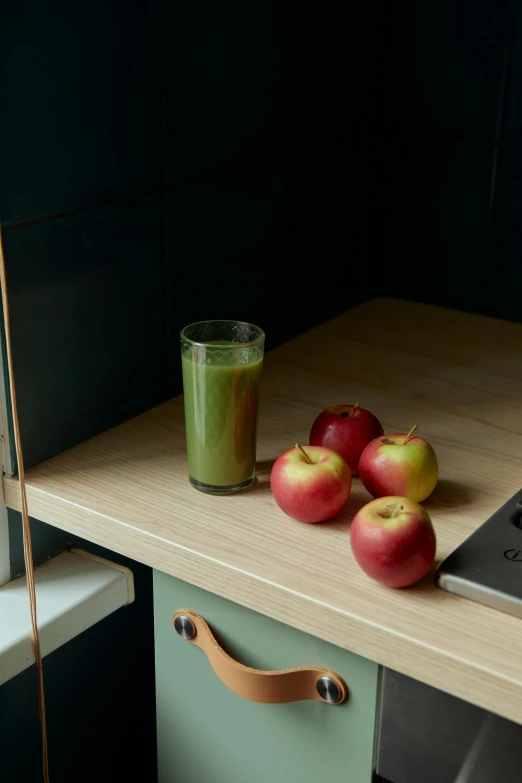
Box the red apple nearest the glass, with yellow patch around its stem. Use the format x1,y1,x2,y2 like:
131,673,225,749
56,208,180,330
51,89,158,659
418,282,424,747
270,445,352,522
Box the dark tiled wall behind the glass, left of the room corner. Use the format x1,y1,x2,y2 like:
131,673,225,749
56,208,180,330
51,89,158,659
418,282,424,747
0,0,383,478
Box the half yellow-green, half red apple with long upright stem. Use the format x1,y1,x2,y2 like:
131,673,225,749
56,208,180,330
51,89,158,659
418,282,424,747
359,427,439,503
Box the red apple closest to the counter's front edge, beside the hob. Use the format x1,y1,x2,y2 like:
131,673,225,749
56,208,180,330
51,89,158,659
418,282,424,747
350,496,437,587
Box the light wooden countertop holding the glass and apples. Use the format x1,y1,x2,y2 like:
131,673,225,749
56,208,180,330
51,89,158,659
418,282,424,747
4,299,522,723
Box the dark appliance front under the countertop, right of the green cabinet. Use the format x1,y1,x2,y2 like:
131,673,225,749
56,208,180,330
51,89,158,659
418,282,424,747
377,668,522,783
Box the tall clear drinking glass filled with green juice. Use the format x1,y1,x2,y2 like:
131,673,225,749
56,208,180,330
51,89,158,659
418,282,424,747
181,321,265,495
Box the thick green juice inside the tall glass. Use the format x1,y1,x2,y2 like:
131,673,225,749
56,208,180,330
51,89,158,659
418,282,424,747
181,342,263,491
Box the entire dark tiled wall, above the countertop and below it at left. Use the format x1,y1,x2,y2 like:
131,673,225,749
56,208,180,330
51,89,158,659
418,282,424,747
0,0,522,783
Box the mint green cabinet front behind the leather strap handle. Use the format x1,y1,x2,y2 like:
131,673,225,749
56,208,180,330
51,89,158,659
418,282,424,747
154,571,378,783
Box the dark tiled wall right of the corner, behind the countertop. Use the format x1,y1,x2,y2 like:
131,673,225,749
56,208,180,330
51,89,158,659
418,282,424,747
375,0,522,320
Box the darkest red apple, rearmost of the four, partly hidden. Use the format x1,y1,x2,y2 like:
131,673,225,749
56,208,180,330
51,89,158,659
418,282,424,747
310,402,384,475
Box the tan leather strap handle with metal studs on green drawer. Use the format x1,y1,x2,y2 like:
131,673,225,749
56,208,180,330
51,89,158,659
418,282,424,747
173,609,348,704
